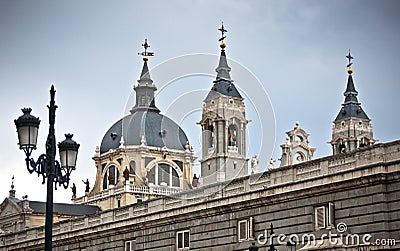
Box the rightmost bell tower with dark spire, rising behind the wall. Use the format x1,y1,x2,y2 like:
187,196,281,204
328,51,377,154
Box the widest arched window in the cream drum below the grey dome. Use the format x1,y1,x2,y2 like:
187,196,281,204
146,163,181,187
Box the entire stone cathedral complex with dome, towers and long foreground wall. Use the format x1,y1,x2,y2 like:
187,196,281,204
0,26,400,251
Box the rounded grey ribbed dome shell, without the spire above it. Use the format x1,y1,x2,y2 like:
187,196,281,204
100,109,188,153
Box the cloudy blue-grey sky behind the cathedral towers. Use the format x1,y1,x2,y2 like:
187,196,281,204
0,0,400,202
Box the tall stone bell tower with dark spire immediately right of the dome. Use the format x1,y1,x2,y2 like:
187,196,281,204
198,24,249,185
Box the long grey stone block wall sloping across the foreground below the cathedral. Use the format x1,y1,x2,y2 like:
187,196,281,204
0,141,400,251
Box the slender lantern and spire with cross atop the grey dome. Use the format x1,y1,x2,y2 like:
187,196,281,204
131,38,160,113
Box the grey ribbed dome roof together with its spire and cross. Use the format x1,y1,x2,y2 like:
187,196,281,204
100,39,188,153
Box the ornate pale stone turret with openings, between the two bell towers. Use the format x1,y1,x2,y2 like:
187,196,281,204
281,122,316,166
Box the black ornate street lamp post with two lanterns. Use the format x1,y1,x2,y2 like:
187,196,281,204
14,85,79,251
